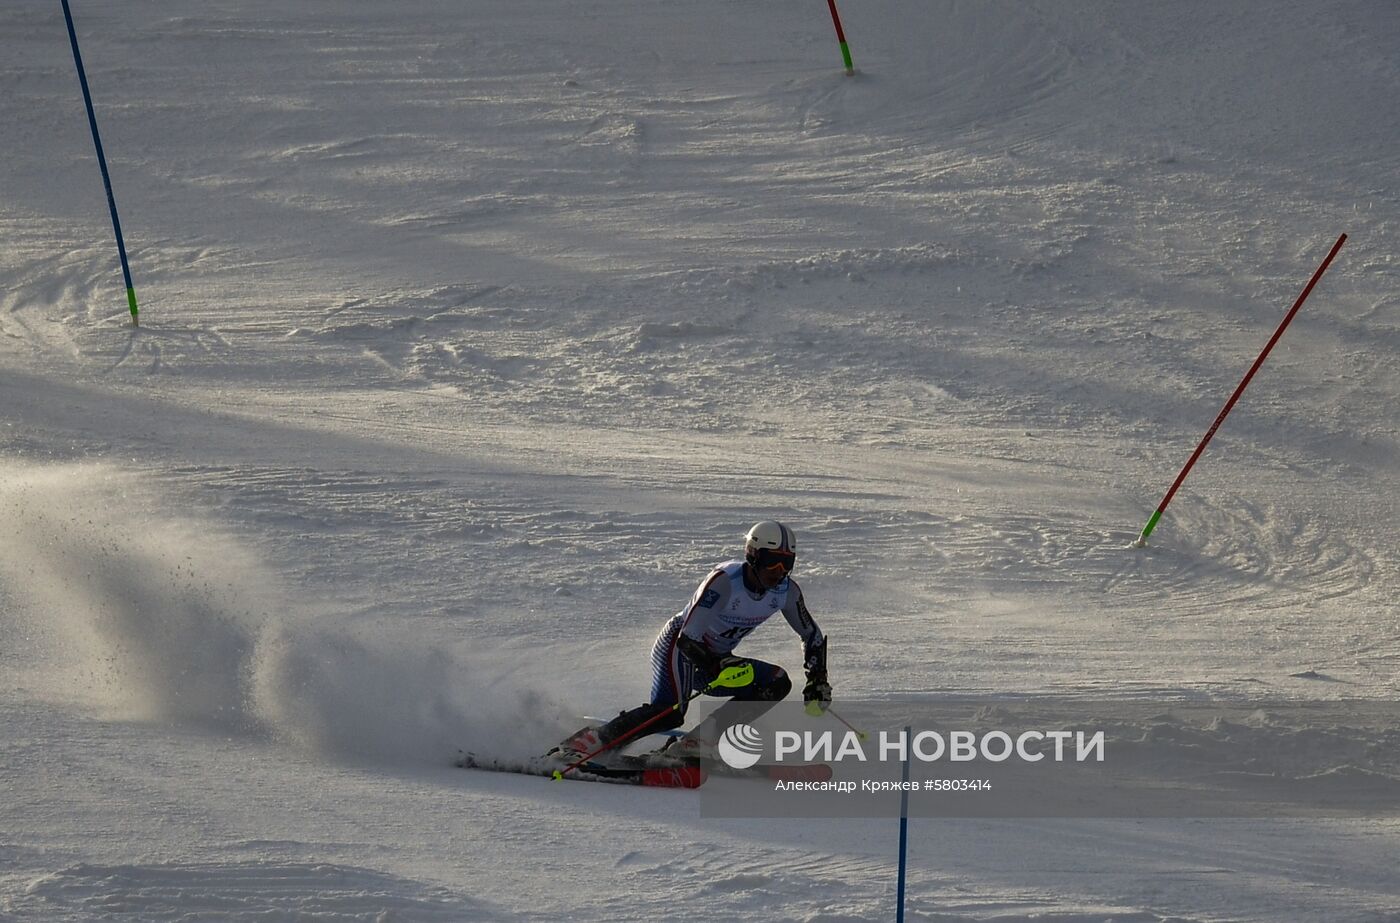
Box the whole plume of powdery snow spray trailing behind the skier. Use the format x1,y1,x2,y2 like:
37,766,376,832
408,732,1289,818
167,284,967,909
0,459,570,766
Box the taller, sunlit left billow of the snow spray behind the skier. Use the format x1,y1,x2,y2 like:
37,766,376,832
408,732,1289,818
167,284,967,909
0,461,266,733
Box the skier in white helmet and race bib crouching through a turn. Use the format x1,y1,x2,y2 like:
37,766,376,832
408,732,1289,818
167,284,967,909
549,521,832,762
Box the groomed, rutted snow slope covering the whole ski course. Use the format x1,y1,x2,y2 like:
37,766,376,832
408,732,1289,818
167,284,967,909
0,0,1400,923
